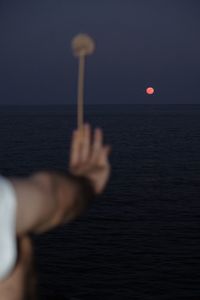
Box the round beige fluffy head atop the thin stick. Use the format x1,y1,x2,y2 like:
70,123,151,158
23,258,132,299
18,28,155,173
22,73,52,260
71,33,95,57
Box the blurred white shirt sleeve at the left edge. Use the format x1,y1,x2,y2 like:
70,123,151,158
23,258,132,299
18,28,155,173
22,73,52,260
0,176,17,280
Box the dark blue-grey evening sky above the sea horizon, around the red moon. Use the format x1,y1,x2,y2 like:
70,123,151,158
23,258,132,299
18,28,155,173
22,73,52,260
0,0,200,104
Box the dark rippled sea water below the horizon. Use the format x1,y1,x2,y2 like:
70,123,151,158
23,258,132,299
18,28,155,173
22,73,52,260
0,105,200,300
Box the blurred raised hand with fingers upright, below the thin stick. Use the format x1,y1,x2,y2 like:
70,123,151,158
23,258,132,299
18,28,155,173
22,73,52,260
69,124,111,194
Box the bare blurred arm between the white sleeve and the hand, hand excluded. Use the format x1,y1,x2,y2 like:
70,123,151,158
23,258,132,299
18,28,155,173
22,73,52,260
11,172,94,235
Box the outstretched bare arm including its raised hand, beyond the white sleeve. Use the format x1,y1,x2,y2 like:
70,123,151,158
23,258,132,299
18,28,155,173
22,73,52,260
11,125,111,235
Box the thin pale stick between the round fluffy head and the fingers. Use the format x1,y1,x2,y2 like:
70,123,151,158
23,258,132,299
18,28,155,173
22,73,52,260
77,55,85,129
